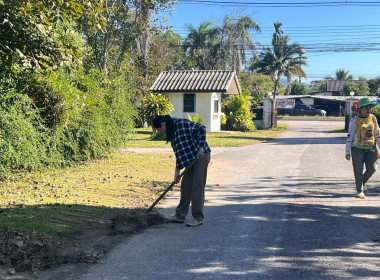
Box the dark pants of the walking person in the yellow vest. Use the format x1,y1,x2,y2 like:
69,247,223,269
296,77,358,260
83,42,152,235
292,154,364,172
351,147,377,193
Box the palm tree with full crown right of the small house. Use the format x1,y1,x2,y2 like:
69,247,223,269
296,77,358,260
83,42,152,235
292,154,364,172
251,22,307,98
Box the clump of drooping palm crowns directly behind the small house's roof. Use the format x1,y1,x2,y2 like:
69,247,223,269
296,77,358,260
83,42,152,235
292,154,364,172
184,15,261,72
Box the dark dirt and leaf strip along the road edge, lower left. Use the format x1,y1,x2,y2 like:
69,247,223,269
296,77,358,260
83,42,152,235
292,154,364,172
0,209,165,279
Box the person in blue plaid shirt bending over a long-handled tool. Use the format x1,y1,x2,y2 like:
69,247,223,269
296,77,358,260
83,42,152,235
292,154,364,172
153,115,211,226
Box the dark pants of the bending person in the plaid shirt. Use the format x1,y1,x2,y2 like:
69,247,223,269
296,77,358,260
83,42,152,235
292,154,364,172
176,153,211,221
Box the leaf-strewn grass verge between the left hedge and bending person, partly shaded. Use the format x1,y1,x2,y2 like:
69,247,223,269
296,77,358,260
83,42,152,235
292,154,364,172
0,152,175,237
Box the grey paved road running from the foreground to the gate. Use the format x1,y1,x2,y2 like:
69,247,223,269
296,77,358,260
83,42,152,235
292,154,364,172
63,121,380,280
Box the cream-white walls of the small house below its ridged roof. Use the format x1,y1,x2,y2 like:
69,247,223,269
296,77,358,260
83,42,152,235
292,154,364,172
169,92,222,132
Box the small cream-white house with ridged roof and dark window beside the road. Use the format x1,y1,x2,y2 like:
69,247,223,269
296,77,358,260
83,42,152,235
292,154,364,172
150,70,241,132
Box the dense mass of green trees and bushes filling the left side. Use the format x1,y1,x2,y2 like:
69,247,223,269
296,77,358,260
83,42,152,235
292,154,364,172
0,0,178,178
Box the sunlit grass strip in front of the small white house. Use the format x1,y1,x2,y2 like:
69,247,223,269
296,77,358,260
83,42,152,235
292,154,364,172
127,124,287,148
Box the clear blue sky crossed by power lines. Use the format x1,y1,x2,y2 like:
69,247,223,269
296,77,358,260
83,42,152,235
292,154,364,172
164,0,380,82
